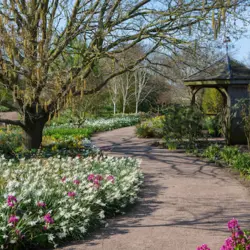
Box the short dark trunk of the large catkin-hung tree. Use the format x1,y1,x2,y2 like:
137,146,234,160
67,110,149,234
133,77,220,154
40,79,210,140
23,119,47,150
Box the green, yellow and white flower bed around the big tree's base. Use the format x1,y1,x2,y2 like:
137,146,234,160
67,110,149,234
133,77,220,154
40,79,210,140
0,115,141,159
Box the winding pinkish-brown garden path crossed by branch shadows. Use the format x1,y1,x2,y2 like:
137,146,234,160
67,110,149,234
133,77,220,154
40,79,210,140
59,127,250,250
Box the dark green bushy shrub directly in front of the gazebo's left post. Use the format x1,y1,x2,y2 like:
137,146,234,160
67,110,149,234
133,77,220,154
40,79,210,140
163,105,204,148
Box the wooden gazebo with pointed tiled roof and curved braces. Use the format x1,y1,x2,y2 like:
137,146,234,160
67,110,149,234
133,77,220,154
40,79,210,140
184,55,250,145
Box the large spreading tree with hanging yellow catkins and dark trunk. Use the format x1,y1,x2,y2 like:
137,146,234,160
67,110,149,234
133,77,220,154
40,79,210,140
0,0,246,149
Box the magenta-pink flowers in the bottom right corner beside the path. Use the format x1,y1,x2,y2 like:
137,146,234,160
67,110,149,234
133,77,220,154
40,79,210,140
197,219,250,250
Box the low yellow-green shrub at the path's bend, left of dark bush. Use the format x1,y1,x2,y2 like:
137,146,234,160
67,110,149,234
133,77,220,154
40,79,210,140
136,116,165,138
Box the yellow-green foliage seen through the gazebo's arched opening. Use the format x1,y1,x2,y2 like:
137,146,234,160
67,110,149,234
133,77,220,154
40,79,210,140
202,88,223,114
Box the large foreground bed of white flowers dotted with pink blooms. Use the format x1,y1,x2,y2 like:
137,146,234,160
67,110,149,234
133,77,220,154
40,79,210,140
0,157,142,249
